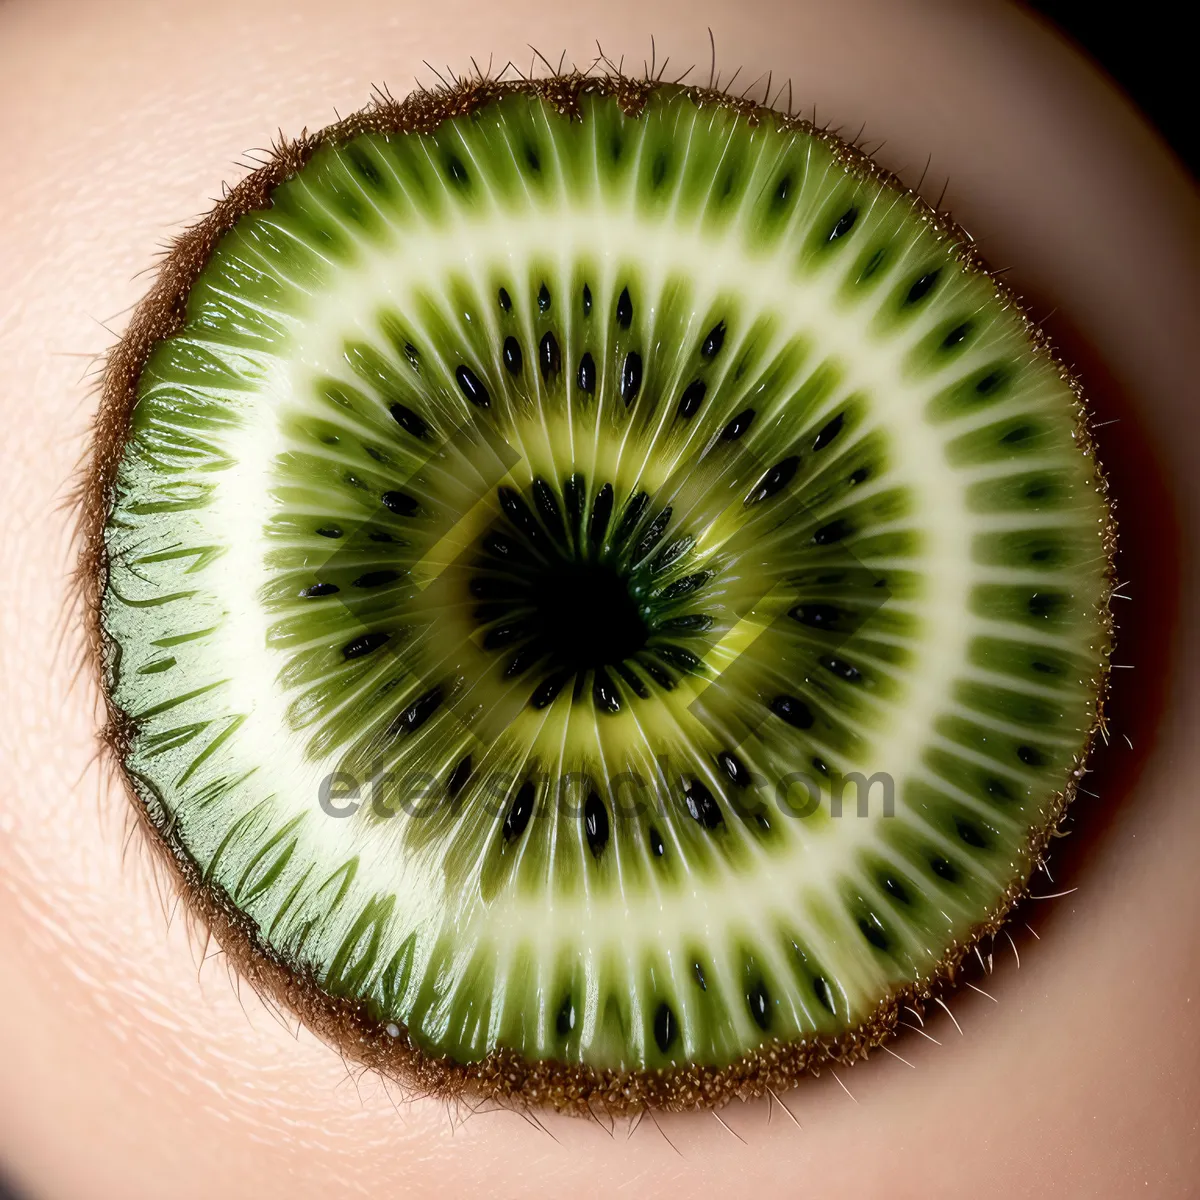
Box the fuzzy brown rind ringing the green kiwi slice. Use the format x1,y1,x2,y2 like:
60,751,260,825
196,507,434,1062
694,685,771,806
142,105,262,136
77,71,1116,1116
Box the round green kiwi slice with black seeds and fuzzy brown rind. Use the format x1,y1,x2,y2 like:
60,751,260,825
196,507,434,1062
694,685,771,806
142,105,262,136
86,76,1114,1110
